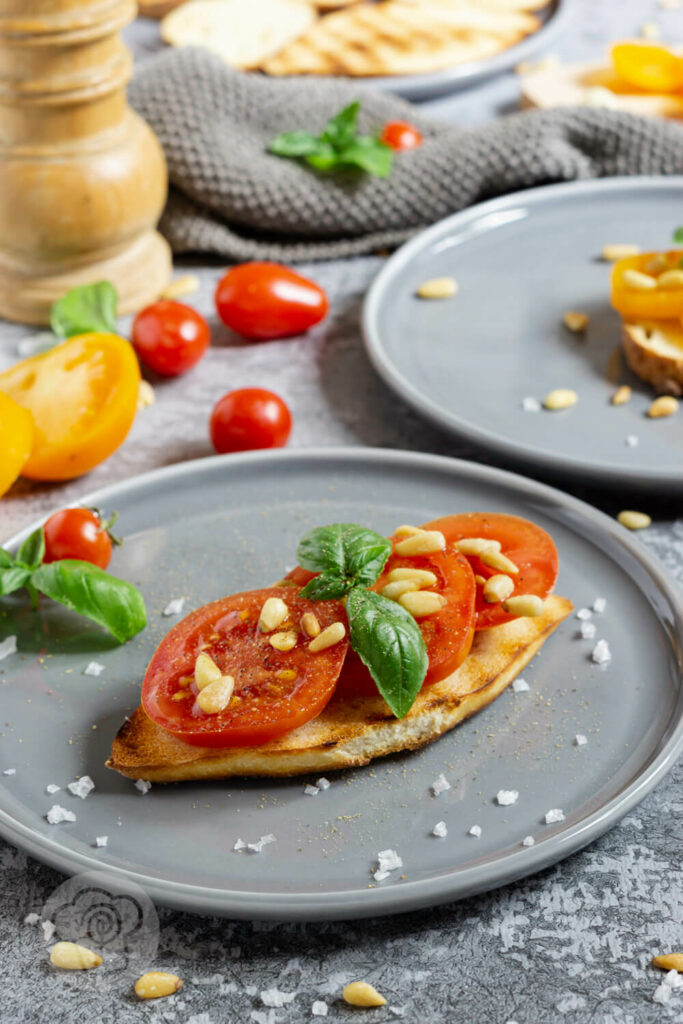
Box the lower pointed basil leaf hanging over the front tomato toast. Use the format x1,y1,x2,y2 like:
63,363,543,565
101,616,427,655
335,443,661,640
346,588,429,718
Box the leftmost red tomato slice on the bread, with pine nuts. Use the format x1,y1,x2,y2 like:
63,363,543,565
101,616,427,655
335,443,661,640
142,587,348,746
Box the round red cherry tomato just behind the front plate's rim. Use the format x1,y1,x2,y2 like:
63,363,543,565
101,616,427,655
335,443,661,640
209,387,292,455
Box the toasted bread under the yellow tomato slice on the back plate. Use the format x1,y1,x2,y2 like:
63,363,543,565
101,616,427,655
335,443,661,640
622,321,683,396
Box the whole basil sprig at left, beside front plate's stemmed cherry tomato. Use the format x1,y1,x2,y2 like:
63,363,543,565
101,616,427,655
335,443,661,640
0,526,147,643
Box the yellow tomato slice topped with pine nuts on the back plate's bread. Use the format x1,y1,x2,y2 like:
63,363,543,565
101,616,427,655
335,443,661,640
610,250,683,319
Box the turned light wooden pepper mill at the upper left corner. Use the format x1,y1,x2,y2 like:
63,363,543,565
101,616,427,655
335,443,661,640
0,0,171,324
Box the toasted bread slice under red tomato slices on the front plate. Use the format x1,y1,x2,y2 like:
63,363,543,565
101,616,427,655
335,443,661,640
106,595,572,782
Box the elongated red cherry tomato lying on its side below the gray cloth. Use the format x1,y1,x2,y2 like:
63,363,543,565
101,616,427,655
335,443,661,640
216,263,329,341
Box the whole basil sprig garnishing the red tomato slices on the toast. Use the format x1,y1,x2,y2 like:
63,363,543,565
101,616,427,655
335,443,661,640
297,522,429,718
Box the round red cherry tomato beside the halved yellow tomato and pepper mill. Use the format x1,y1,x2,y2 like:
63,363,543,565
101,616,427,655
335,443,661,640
132,299,211,377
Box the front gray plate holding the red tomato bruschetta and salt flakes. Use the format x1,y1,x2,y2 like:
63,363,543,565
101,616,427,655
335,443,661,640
0,449,683,919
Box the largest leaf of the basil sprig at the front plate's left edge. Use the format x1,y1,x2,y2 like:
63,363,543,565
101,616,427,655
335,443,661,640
32,558,146,643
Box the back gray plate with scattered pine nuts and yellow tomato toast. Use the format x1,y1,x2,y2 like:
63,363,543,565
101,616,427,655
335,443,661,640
364,177,683,492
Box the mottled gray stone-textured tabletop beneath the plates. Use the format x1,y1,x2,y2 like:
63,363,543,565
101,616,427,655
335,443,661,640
0,0,683,1024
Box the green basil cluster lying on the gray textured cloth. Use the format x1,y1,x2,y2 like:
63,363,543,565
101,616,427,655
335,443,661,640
268,100,393,178
